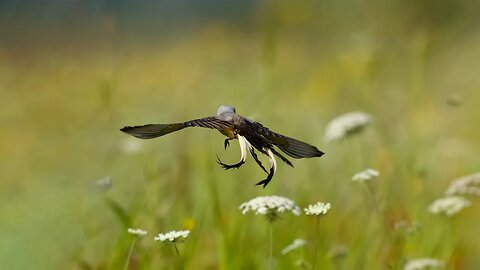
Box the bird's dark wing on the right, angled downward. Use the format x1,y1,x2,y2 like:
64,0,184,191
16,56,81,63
247,121,324,159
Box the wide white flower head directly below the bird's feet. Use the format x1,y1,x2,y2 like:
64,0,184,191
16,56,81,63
240,195,301,221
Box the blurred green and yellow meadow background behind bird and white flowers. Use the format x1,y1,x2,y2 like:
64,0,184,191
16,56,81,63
0,0,480,269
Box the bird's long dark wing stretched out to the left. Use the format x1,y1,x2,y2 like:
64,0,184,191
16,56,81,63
120,117,233,139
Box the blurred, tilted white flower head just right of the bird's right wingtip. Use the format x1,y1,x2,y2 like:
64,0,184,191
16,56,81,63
323,112,370,142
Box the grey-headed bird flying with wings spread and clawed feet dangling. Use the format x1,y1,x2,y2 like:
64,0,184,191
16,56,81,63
120,105,324,188
